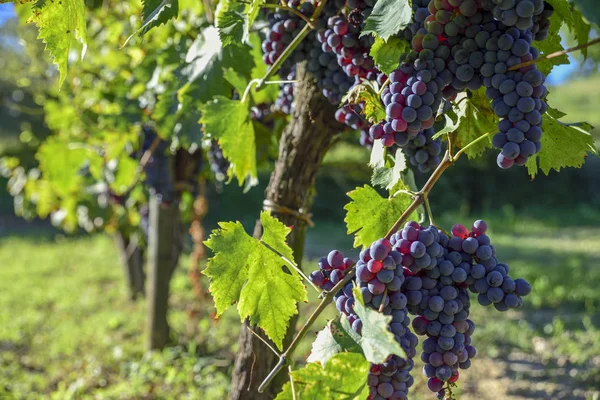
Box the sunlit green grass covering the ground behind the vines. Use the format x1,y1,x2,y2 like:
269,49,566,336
0,218,600,400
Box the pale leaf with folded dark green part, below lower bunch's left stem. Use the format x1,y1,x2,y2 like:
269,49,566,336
306,316,362,366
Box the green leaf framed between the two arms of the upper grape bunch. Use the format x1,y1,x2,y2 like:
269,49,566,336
446,88,498,158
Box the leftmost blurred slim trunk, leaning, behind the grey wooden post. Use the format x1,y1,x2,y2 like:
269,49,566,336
113,231,145,300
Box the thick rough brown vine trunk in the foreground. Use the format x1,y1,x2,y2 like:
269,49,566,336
230,64,344,400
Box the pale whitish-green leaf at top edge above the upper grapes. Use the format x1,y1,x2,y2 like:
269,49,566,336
360,0,412,41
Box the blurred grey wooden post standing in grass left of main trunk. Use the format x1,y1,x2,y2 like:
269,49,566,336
146,195,183,350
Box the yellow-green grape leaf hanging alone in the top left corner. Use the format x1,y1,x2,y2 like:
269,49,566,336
28,0,87,87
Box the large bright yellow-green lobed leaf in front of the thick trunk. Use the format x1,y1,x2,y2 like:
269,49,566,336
204,211,307,349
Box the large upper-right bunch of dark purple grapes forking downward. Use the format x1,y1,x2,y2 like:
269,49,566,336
371,0,552,169
